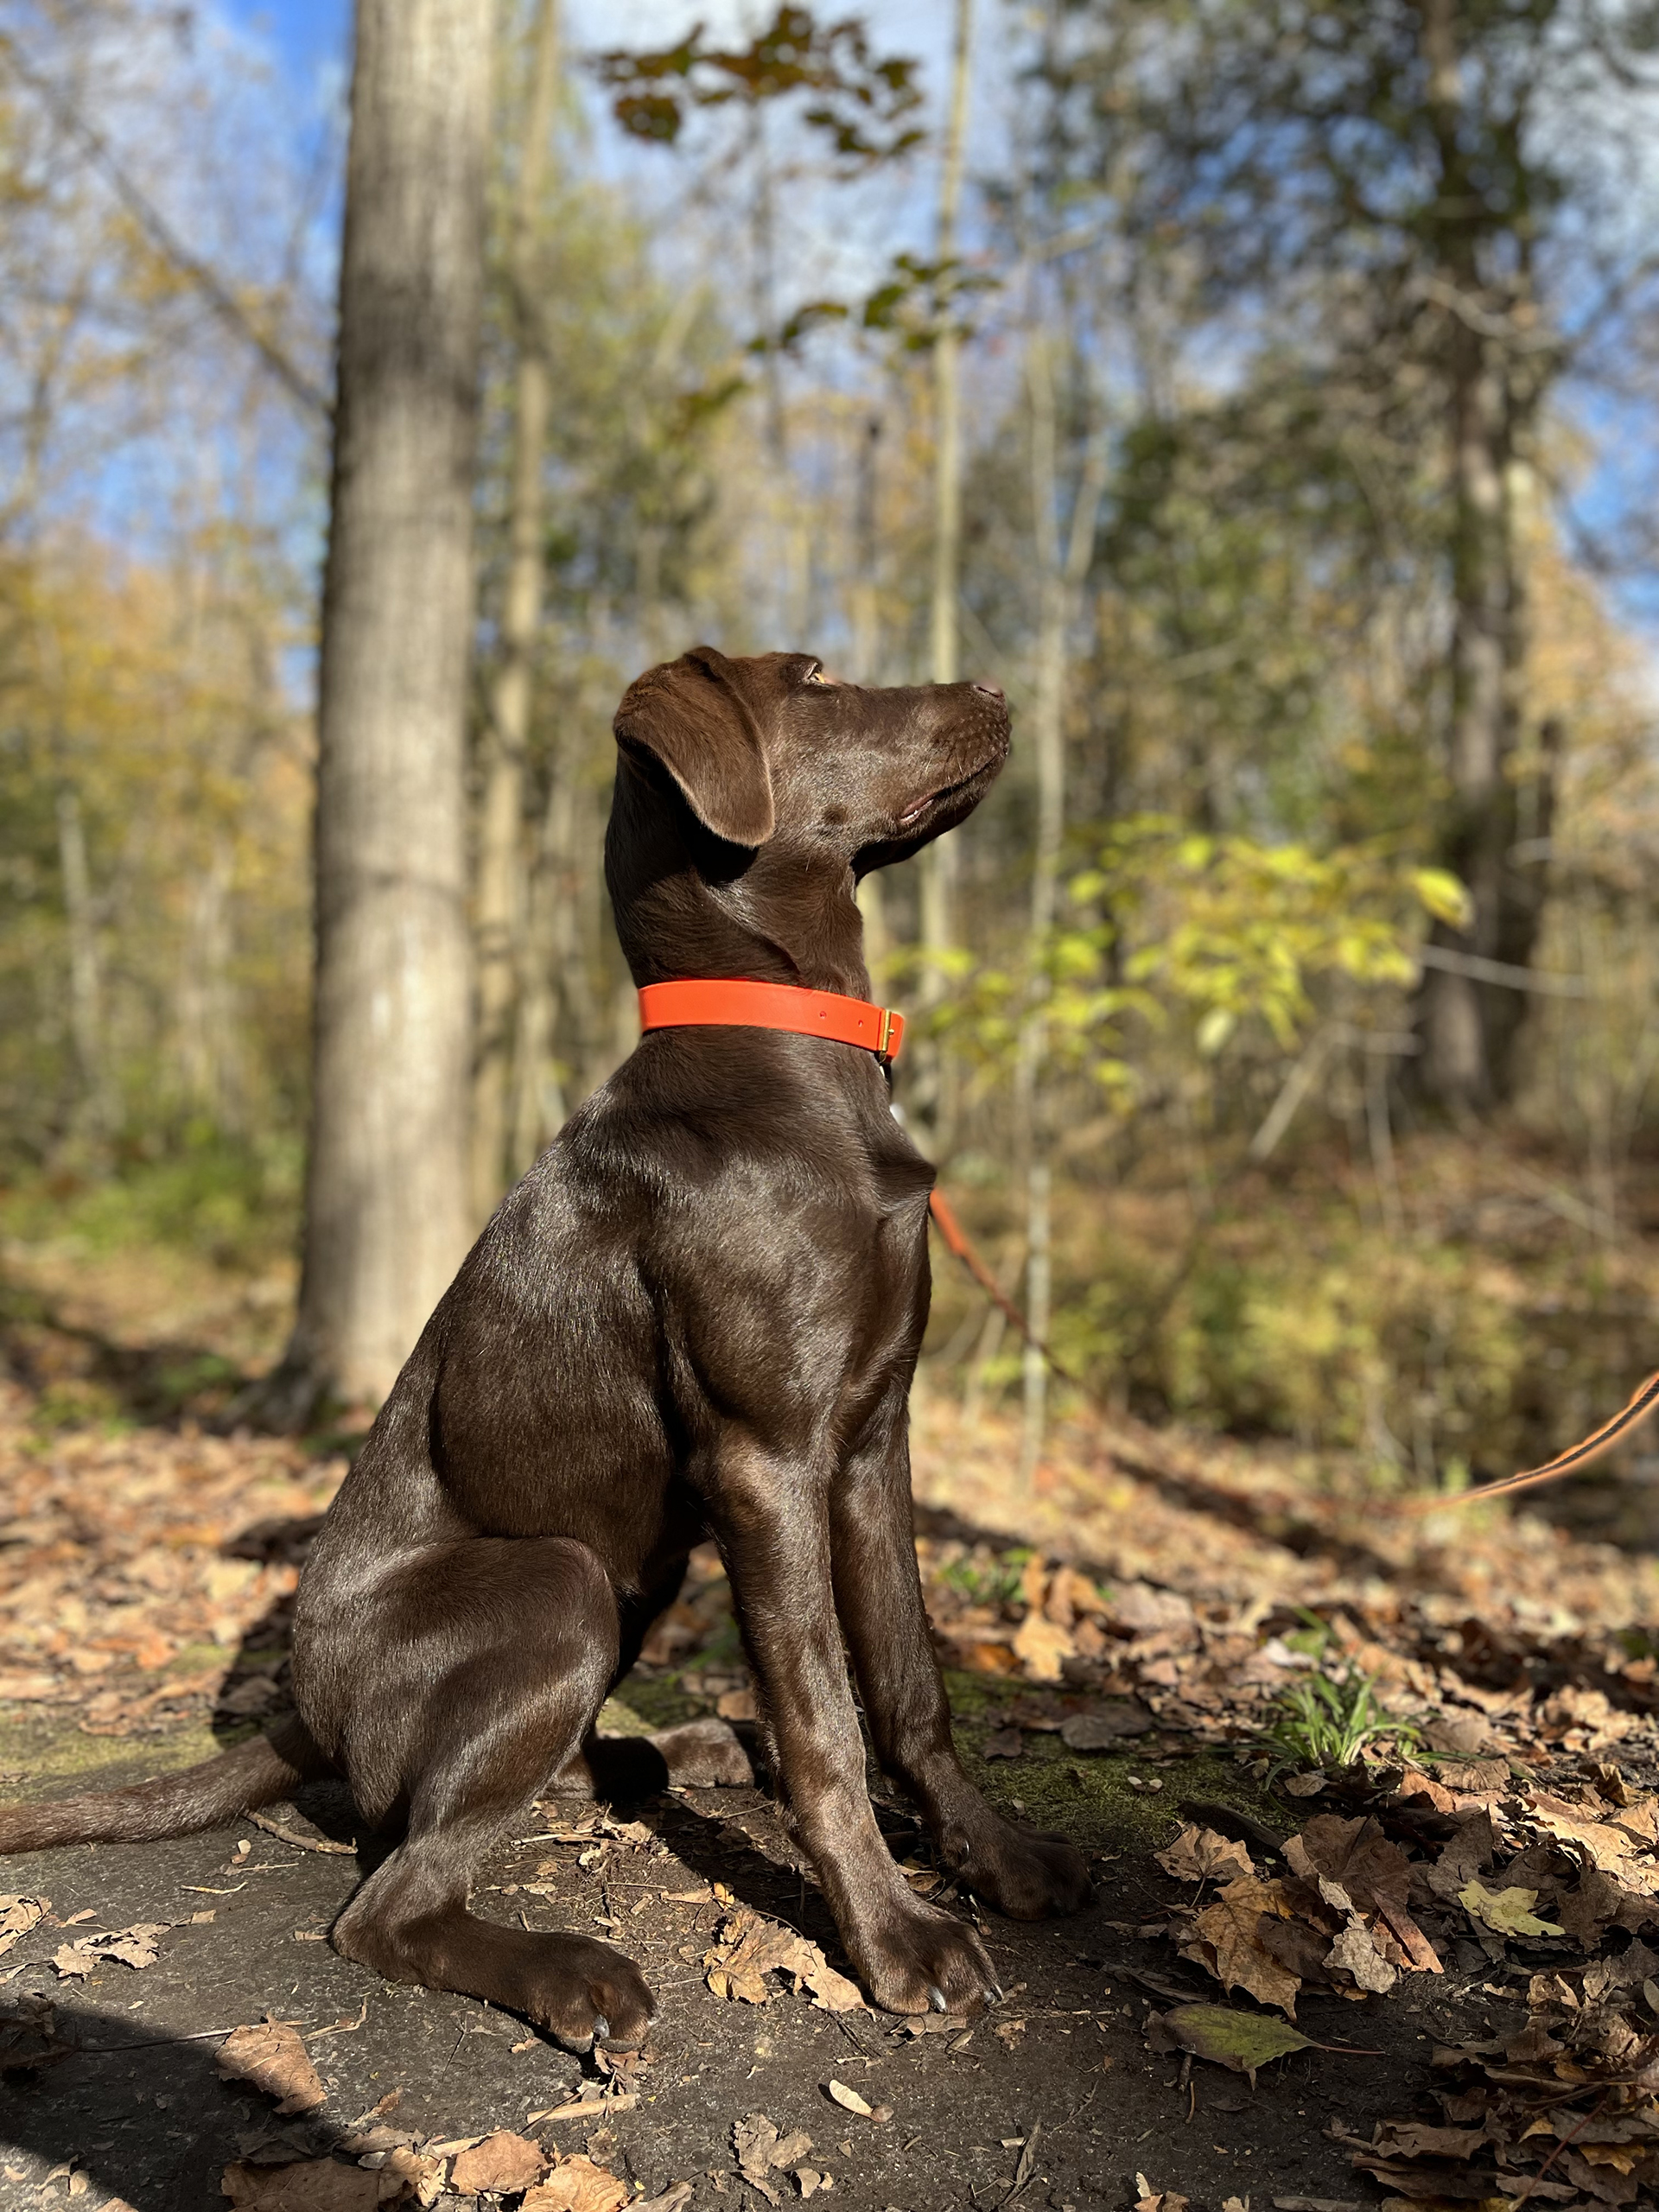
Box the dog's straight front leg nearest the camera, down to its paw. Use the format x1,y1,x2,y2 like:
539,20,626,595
710,1442,998,2013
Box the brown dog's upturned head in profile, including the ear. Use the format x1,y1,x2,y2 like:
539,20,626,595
615,646,1008,878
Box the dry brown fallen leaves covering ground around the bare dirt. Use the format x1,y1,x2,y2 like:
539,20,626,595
16,1300,1659,2212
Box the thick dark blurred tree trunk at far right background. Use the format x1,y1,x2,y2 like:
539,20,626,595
1415,0,1553,1119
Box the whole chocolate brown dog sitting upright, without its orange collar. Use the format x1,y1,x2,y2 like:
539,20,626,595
0,646,1089,2049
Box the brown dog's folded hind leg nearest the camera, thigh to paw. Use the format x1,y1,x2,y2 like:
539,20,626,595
319,1537,651,2050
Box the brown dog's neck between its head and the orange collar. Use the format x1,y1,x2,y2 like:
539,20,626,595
606,767,869,998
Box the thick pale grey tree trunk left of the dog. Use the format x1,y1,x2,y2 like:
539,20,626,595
285,0,495,1411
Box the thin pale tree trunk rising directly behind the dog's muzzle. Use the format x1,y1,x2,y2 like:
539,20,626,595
918,0,973,1153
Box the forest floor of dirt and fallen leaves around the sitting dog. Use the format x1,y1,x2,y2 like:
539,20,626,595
0,1248,1659,2212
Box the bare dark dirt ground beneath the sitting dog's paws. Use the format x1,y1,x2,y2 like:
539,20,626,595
0,1725,1491,2212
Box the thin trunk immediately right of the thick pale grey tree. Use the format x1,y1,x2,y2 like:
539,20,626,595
471,0,560,1221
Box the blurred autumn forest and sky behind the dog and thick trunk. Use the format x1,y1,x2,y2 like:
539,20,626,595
0,0,1659,1484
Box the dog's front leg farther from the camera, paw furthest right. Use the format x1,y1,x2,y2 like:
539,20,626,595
830,1394,1089,1920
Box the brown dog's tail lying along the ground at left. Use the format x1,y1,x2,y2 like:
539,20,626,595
0,1719,332,1853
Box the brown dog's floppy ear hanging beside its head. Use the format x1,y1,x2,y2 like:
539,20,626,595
615,646,777,845
